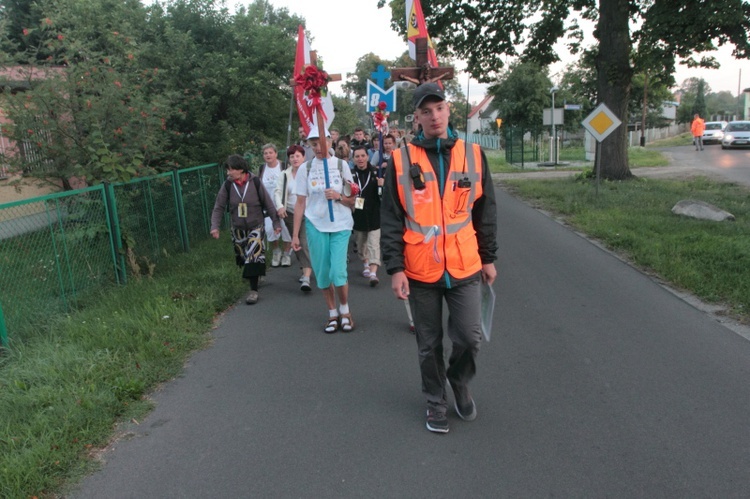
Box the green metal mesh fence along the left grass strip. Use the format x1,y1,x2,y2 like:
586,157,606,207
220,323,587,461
0,164,224,346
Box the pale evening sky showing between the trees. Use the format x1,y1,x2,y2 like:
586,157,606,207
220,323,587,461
256,0,750,103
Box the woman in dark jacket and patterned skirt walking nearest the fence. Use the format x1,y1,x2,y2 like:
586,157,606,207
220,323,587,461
211,154,281,305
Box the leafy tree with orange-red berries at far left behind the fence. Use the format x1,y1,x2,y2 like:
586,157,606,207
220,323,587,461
4,0,172,189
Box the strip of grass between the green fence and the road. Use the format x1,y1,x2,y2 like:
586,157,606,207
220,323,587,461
0,238,245,498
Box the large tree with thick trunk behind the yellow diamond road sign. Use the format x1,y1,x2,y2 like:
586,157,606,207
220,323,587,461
379,0,750,179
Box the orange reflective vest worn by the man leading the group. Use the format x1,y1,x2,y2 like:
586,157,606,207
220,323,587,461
393,140,482,283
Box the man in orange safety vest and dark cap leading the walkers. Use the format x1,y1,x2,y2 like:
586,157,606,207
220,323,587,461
381,83,497,433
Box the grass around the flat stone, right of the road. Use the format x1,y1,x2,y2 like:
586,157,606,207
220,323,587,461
504,178,750,324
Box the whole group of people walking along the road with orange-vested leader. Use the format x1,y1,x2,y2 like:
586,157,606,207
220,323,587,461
211,83,497,433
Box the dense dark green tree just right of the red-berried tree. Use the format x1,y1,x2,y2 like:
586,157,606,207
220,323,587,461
148,0,303,164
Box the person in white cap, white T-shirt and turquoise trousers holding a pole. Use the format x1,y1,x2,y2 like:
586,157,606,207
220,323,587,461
292,127,356,334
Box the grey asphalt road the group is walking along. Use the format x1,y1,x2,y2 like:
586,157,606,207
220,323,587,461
73,186,750,498
